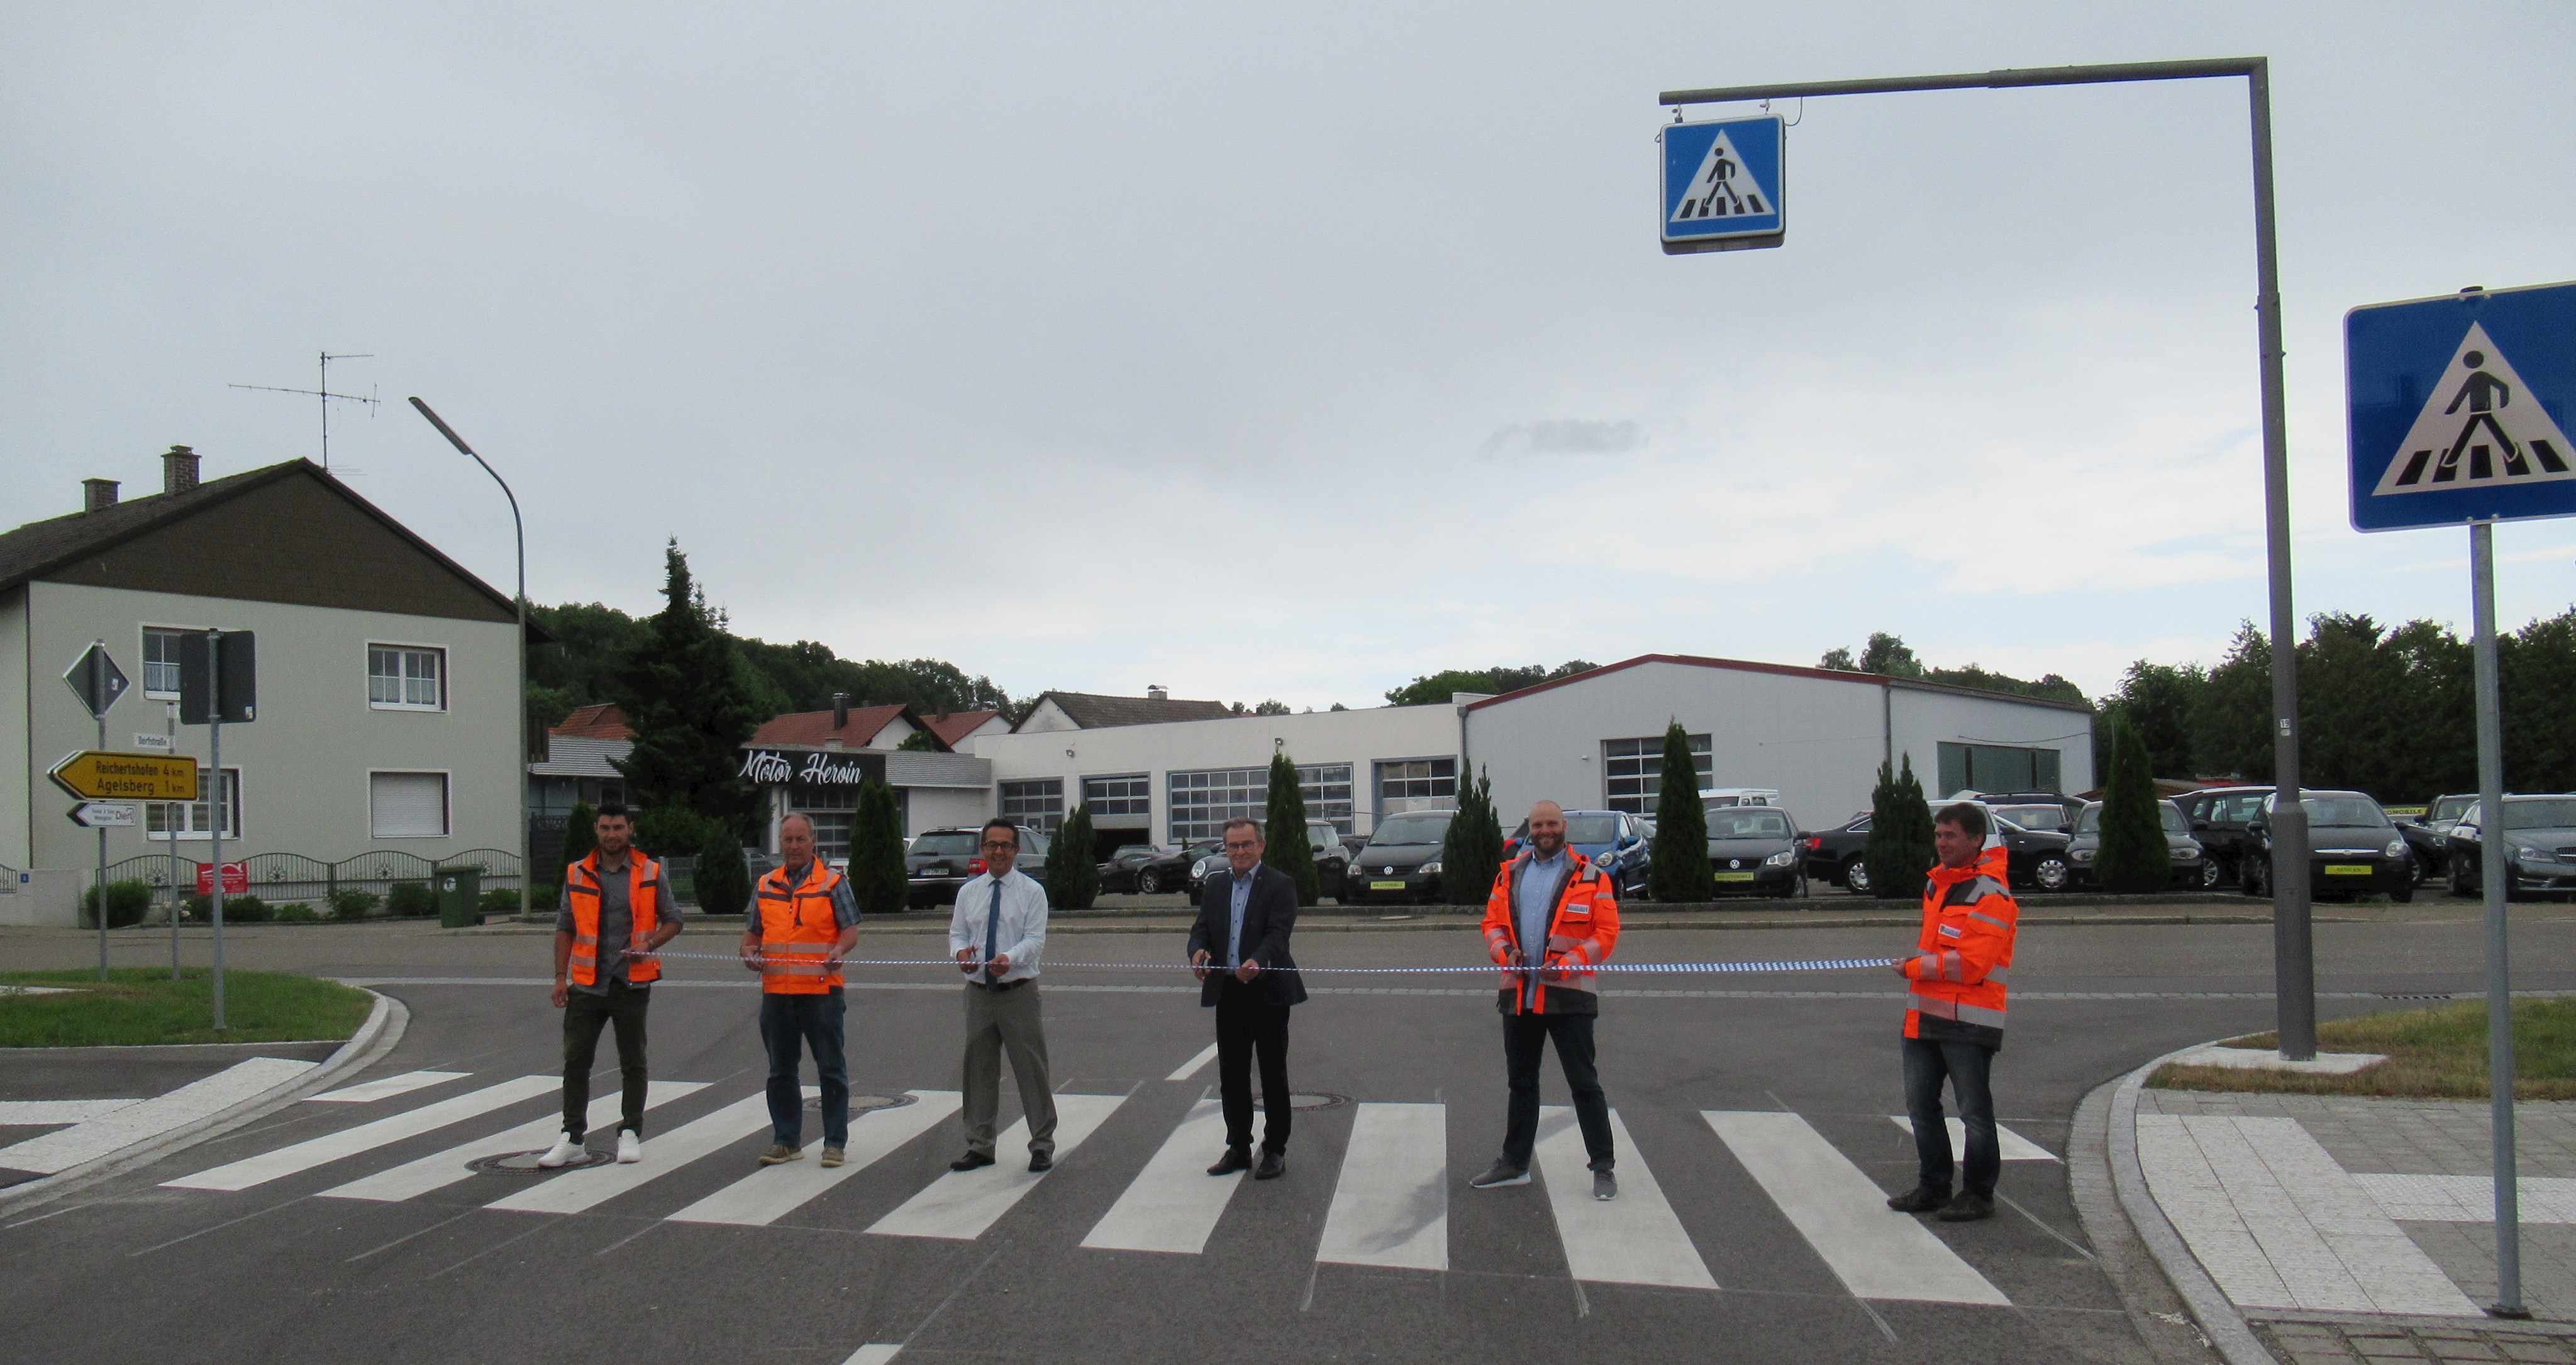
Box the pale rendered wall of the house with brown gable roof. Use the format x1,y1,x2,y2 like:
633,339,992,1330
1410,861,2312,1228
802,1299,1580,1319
18,582,520,868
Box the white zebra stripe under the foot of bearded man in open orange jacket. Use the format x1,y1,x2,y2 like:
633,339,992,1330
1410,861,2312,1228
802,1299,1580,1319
1533,1105,1718,1290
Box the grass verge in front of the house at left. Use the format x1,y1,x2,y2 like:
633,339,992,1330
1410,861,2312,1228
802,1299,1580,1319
0,968,376,1048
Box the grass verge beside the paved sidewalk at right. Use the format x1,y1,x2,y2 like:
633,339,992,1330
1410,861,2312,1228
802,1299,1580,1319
2146,999,2576,1100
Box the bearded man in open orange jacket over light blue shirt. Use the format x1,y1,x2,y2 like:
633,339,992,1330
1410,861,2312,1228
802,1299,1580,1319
1468,801,1618,1200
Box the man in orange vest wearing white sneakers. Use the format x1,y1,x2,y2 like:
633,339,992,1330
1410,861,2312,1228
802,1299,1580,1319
536,801,680,1169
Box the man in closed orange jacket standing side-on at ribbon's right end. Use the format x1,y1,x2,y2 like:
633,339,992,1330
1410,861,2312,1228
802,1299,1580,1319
1888,801,2022,1224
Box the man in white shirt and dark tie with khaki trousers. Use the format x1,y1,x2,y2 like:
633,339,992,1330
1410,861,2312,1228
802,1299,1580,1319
948,819,1056,1172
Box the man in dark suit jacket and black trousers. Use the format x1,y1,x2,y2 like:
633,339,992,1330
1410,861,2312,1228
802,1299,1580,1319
1190,819,1306,1180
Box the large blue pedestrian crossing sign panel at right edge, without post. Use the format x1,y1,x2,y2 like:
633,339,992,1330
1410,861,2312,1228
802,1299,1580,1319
2344,284,2576,531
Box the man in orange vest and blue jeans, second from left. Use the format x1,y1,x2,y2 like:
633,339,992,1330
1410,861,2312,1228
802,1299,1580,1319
742,814,858,1167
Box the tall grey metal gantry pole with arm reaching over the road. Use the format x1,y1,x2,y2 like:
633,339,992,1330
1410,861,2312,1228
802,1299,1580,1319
1659,57,2316,1059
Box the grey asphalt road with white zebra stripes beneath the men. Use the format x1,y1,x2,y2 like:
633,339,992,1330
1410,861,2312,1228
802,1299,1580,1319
0,907,2576,1365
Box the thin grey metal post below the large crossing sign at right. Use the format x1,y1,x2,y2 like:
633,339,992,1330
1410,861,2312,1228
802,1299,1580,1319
2468,520,2532,1318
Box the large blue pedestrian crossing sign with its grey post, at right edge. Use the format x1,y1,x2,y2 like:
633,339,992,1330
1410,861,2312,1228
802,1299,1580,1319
2344,273,2576,1318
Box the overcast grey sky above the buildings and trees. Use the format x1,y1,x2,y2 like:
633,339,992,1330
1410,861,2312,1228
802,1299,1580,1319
0,0,2576,708
